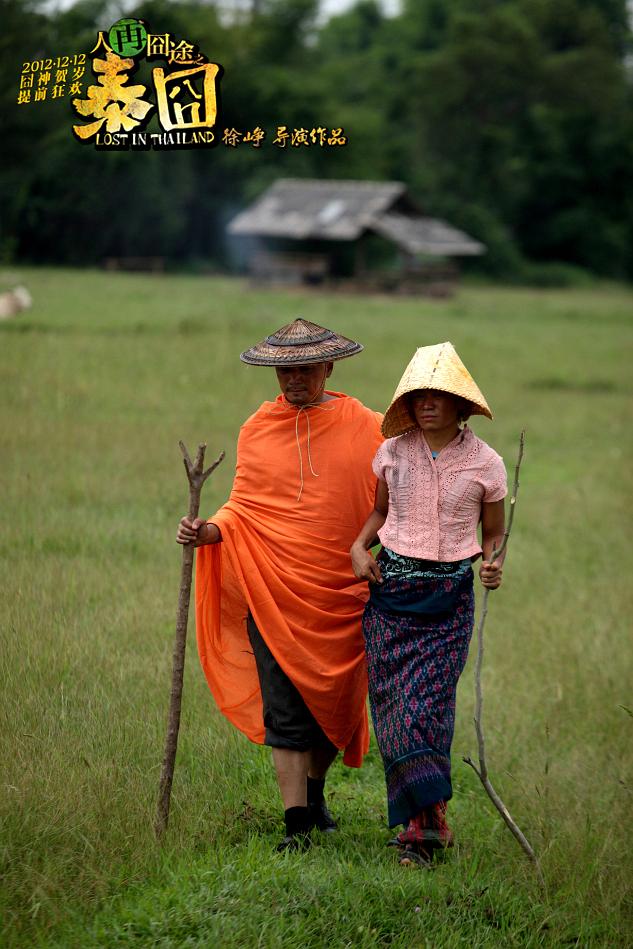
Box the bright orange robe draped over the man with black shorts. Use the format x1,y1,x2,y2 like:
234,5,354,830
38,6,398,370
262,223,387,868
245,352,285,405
196,392,382,767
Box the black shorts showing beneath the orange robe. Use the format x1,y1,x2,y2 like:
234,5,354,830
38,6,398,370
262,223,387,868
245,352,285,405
246,612,335,751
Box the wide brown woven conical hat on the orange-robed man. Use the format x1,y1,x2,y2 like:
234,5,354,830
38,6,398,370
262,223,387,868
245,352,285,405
240,319,363,366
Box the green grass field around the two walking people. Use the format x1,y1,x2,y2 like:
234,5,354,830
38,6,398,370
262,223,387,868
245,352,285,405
0,269,633,949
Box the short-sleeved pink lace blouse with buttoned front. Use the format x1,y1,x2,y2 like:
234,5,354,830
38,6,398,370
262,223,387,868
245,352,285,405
373,426,507,562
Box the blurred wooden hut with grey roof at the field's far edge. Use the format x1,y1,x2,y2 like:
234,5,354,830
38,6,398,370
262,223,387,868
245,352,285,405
228,178,486,292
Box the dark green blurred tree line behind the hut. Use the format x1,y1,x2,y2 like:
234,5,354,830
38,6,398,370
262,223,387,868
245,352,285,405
0,0,633,279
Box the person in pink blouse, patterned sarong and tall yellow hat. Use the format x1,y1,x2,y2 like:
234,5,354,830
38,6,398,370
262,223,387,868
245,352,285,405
350,343,507,864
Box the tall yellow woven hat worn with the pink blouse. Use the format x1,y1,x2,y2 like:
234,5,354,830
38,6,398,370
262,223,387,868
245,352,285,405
382,343,492,438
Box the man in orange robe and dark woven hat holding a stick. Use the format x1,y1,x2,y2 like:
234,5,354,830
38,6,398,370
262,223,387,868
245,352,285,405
177,320,381,849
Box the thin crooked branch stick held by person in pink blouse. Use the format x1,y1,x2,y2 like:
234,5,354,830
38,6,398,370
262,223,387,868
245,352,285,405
463,432,545,886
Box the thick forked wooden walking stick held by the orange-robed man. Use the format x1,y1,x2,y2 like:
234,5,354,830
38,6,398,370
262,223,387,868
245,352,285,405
154,442,224,837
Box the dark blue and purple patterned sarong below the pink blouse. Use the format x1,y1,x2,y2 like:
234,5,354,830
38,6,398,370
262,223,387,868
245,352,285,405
363,548,474,827
